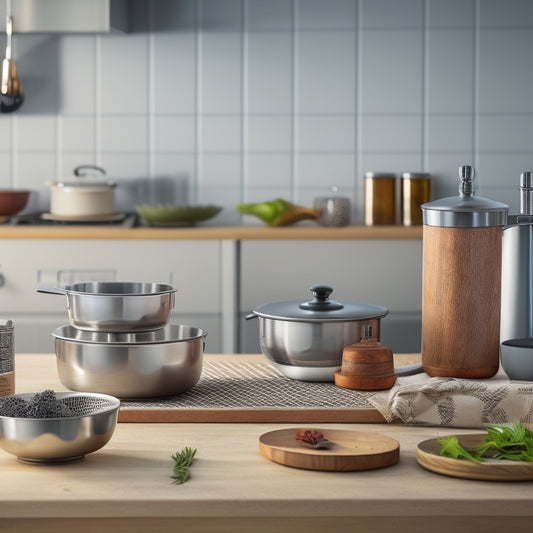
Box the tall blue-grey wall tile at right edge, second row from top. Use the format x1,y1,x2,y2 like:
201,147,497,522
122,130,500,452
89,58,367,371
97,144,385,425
479,28,533,114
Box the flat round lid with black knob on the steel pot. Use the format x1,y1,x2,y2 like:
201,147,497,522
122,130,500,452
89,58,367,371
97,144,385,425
249,285,388,322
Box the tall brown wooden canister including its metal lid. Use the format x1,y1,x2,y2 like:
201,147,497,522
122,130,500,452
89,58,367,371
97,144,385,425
422,166,509,378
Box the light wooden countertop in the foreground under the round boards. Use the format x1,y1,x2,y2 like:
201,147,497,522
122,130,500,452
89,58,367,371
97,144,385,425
0,354,533,533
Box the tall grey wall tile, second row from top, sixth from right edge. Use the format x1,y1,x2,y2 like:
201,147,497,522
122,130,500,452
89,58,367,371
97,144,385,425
198,32,242,114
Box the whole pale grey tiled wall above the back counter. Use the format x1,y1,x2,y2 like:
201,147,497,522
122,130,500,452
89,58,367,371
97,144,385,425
5,0,533,214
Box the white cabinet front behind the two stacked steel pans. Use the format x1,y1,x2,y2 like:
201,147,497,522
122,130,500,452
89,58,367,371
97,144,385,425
0,239,223,352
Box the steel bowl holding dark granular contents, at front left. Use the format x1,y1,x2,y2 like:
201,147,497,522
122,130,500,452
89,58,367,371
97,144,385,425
0,392,120,463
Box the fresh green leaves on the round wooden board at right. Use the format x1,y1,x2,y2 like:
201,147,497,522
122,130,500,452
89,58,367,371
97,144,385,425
437,423,533,463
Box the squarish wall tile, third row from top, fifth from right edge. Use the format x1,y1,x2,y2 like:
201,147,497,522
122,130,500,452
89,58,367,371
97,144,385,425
246,115,292,152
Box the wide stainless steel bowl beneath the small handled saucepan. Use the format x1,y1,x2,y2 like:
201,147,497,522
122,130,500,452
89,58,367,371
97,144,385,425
52,324,207,398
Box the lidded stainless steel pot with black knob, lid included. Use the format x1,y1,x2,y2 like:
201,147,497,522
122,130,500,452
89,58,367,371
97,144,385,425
246,285,388,381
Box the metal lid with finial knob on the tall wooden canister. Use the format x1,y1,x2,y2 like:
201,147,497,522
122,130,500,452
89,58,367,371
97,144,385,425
421,166,509,228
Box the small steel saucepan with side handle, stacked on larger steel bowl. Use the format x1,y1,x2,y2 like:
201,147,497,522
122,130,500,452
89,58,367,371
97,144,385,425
37,281,176,333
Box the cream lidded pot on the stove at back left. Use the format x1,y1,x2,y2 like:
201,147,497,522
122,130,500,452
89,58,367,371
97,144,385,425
45,165,117,218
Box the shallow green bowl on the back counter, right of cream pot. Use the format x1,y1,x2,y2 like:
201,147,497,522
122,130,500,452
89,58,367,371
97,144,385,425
136,204,222,226
